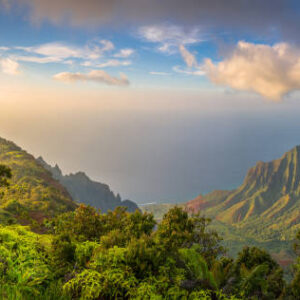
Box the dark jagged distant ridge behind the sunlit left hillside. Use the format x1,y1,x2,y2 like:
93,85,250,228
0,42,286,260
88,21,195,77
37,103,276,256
37,157,138,212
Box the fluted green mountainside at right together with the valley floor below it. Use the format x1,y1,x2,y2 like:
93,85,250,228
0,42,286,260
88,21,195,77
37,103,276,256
142,146,300,265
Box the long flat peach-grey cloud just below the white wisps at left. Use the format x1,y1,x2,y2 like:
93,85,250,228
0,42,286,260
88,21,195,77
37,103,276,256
53,70,129,86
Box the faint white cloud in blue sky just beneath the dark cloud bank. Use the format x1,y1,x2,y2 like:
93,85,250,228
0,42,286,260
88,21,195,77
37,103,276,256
139,25,202,53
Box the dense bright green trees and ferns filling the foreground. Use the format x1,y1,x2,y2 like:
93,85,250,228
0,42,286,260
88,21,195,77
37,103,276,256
0,166,300,300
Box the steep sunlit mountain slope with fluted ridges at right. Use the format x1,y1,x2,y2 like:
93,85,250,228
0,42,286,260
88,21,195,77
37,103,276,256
186,146,300,241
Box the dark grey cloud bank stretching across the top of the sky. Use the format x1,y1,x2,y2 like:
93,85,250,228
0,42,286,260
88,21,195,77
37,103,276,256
4,0,300,41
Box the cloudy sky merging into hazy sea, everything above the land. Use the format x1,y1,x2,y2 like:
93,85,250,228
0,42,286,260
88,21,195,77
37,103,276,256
0,0,300,203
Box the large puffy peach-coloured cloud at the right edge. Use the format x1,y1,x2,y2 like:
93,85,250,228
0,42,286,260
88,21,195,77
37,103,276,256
204,42,300,100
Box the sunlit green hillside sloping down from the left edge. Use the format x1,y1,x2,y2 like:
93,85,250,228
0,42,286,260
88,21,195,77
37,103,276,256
0,138,77,224
